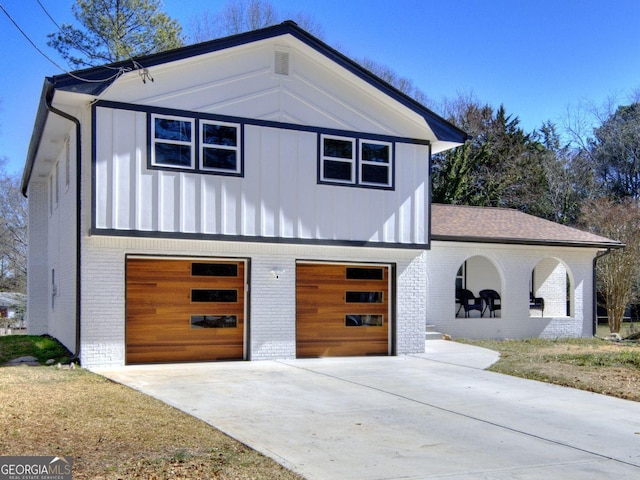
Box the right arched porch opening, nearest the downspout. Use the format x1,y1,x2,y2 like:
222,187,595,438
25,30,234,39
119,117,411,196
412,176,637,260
529,258,573,317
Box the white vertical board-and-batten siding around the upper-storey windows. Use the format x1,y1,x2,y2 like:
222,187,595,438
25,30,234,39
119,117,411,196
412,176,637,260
94,107,429,244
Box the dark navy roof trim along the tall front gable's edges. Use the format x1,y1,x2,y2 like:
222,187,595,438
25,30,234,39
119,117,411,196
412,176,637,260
48,20,470,143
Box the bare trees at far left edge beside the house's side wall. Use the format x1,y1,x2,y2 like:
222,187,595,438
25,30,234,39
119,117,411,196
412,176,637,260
0,158,27,293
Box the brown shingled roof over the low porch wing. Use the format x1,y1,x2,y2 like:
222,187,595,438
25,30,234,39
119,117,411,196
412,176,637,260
431,203,624,248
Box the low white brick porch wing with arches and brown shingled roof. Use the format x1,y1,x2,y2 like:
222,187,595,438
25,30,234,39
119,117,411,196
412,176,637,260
426,205,616,339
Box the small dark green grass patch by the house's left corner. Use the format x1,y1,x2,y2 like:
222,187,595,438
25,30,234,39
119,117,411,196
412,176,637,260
0,335,71,365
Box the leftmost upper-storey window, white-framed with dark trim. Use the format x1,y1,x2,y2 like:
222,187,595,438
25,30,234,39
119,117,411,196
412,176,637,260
151,115,195,169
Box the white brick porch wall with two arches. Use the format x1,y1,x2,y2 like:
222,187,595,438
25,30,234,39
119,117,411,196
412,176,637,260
427,242,596,338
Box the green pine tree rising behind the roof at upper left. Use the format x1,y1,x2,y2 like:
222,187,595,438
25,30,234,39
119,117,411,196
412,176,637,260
47,0,183,68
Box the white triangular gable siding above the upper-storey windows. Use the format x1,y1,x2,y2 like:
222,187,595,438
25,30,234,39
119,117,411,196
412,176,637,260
102,36,435,141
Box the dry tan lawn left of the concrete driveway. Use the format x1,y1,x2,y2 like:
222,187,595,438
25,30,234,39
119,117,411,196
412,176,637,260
0,366,301,479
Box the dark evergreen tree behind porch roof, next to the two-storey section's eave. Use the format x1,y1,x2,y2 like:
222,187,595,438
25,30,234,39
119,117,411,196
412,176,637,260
432,97,548,217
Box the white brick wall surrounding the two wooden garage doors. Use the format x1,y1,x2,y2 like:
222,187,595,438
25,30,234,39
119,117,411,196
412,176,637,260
81,236,426,367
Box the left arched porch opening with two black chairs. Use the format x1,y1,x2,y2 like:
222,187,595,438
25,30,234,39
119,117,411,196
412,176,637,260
455,255,502,318
